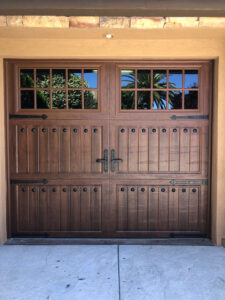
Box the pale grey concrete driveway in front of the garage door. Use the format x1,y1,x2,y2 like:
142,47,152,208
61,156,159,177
0,245,225,300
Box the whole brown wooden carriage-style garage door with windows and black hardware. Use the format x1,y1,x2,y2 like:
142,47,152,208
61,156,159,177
6,60,211,237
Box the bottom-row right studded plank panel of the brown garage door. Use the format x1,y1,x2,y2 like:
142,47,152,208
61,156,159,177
115,183,207,232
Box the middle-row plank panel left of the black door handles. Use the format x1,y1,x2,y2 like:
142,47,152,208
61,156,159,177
11,124,108,176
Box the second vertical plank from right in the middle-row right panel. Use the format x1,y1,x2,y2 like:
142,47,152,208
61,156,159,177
180,128,190,172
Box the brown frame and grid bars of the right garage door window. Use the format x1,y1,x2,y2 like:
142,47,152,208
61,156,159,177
119,66,201,112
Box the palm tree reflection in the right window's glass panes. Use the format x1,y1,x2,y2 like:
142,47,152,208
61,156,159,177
122,72,181,109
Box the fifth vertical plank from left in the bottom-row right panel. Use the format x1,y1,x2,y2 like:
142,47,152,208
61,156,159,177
159,187,169,230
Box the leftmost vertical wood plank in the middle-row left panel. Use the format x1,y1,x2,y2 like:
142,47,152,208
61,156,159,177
17,125,28,173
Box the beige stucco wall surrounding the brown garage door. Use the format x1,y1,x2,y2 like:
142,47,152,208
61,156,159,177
0,28,225,245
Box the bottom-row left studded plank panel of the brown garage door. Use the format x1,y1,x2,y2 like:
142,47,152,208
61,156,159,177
13,184,103,234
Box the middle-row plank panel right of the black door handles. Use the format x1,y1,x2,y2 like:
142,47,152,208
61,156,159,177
111,124,202,175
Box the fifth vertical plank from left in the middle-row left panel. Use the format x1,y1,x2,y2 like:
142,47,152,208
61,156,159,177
60,127,70,173
